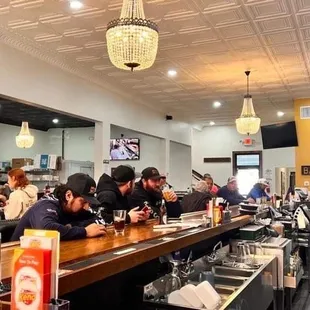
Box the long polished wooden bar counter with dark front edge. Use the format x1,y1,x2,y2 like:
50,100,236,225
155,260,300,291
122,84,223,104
1,215,251,296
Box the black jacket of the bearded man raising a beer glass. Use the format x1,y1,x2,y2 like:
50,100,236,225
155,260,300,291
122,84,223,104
128,181,182,218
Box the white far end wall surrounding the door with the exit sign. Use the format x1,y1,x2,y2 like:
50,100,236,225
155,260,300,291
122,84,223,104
192,126,295,189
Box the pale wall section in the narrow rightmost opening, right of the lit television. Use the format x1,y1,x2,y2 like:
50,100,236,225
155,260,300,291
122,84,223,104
167,142,192,190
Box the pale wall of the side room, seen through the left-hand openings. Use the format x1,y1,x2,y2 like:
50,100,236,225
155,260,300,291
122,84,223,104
0,124,191,190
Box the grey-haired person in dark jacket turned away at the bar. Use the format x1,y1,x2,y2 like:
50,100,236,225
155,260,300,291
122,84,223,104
182,181,213,213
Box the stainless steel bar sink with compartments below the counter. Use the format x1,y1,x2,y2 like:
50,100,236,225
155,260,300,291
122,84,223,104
144,256,276,310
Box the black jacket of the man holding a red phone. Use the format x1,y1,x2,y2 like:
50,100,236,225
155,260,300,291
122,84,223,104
96,173,130,224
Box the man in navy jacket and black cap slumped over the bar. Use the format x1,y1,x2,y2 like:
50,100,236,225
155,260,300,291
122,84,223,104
11,173,106,241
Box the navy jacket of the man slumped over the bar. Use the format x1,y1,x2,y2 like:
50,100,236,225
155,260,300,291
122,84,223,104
11,195,98,241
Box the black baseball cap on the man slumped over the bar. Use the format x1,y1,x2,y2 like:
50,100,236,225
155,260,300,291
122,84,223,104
66,173,100,205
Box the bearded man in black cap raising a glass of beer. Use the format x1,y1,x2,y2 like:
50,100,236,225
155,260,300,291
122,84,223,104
129,167,182,218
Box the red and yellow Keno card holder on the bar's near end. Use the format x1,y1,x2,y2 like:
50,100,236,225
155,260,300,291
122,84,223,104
9,229,66,310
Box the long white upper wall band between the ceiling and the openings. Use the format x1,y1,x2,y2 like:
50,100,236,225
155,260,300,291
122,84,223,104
0,43,191,145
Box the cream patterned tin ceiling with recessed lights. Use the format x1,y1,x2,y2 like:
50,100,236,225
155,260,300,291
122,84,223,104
0,0,310,125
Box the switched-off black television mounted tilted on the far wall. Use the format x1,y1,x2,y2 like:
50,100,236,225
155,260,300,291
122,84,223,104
261,122,298,149
